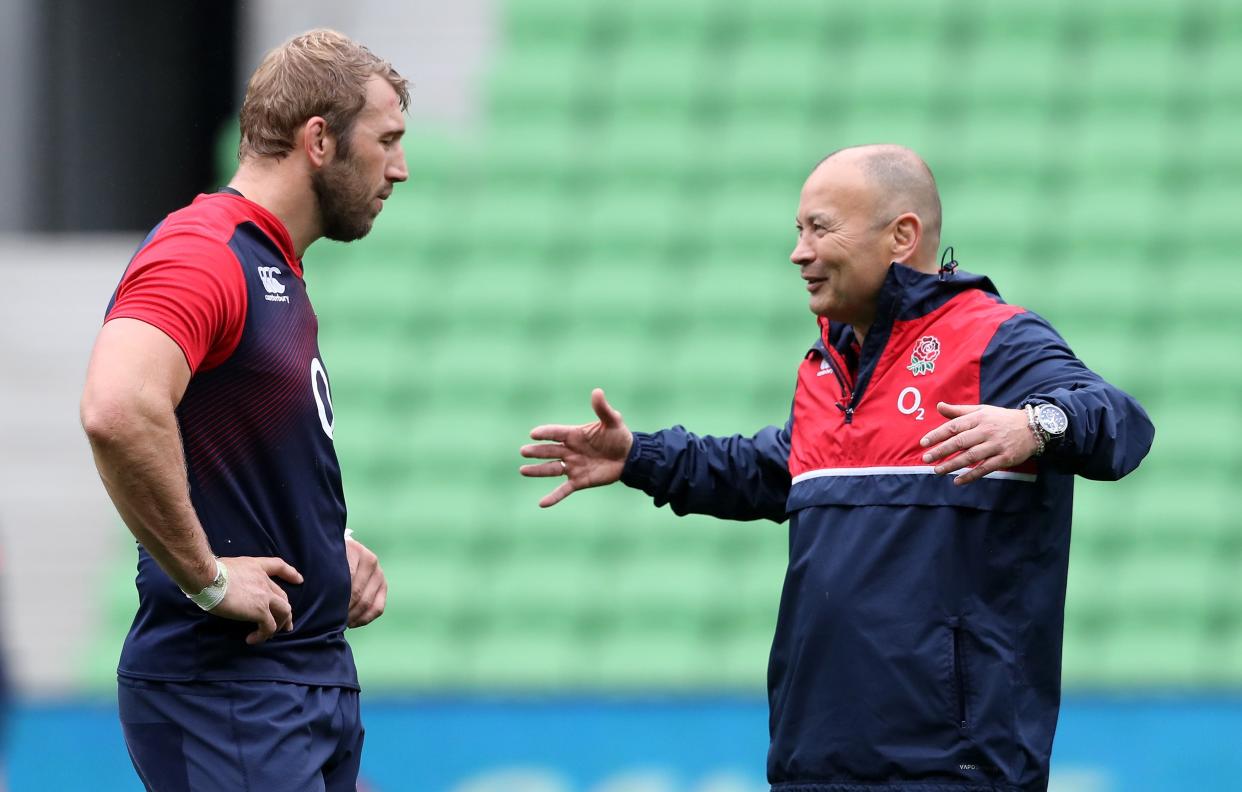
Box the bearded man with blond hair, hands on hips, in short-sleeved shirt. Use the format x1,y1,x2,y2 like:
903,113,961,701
81,30,409,792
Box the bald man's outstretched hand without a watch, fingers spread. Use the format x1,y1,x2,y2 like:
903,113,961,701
520,389,633,509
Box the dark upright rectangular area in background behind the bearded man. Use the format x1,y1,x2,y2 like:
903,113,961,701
26,0,240,231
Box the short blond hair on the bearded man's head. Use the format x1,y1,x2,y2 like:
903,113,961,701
237,29,410,160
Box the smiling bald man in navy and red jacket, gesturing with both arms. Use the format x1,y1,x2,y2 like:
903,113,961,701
522,145,1154,792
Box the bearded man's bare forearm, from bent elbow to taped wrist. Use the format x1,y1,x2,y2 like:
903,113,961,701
82,397,216,592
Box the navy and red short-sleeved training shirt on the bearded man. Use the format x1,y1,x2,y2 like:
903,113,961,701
106,191,358,688
